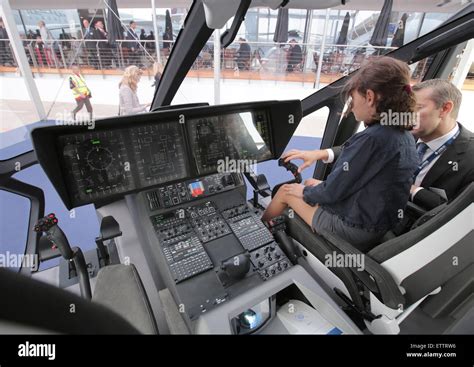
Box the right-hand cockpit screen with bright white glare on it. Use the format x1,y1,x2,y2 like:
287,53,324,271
187,111,272,174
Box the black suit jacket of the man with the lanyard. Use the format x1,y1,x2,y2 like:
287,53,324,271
331,123,474,210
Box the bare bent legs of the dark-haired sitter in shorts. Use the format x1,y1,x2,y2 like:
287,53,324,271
262,185,318,227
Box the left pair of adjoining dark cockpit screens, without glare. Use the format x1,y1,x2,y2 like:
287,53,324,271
59,122,189,204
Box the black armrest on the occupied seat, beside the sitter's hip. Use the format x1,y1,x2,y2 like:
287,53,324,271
319,230,405,309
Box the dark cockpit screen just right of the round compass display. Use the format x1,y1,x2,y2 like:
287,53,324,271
131,122,187,187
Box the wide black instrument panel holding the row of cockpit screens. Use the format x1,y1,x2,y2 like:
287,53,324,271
31,100,302,209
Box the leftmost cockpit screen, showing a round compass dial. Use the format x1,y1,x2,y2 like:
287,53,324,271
59,130,135,203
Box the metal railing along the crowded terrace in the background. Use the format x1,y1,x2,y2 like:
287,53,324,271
0,39,430,85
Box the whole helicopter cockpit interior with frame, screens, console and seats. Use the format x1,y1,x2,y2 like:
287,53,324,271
0,0,474,335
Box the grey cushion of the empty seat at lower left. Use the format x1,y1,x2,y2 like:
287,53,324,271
92,264,158,334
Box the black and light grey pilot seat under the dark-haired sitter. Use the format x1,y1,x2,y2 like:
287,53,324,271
285,183,474,334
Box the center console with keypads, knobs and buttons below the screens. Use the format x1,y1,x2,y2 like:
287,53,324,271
140,173,292,321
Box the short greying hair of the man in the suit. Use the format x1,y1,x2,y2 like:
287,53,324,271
413,79,462,119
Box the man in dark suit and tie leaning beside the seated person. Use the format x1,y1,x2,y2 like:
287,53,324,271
286,79,474,210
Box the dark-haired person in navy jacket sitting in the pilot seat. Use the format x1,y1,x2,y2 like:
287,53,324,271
262,57,418,251
